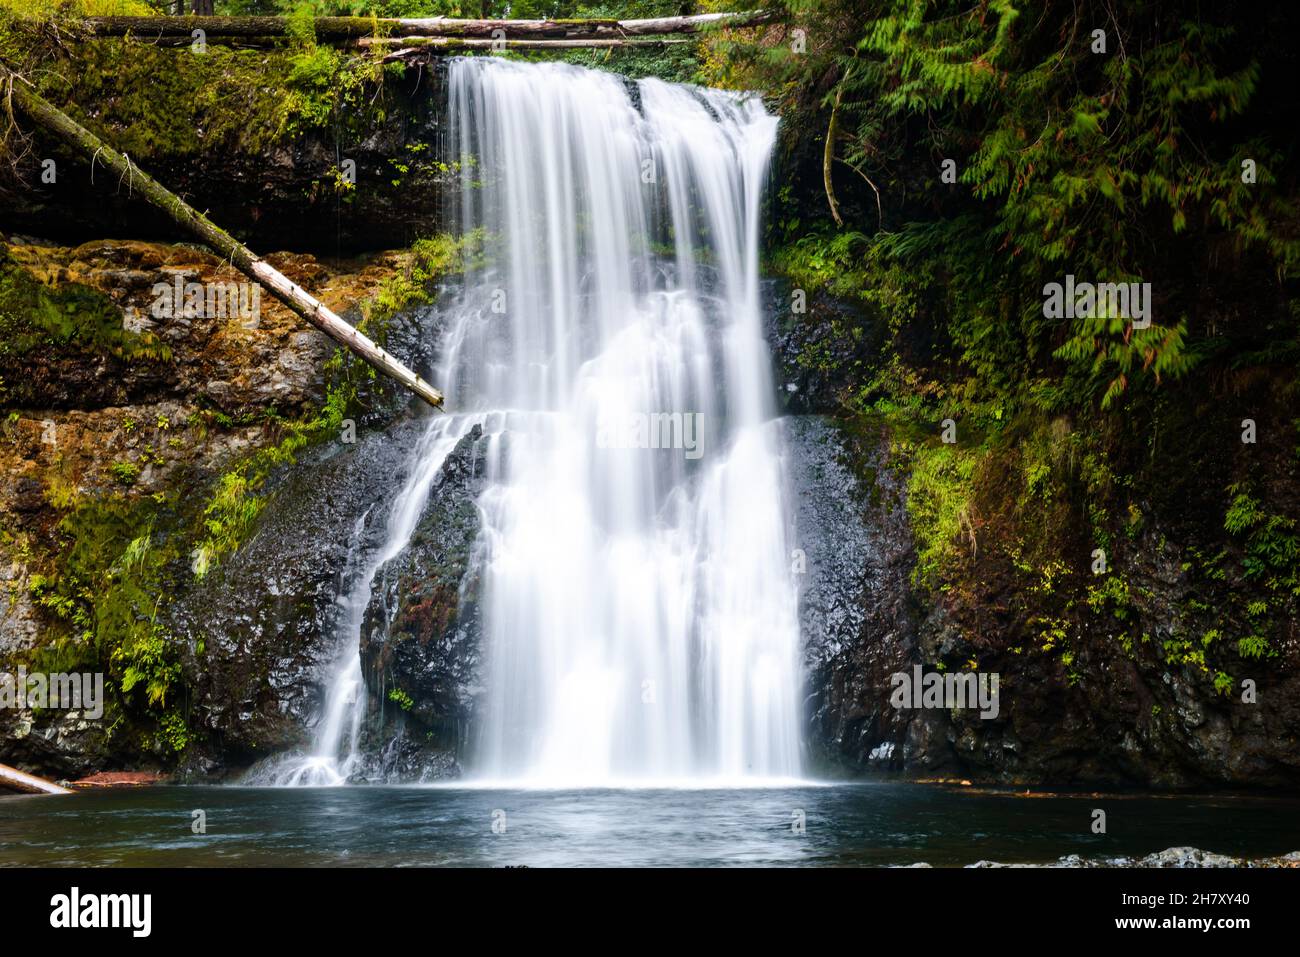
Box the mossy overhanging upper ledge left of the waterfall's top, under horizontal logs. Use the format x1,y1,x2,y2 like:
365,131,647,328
0,0,449,255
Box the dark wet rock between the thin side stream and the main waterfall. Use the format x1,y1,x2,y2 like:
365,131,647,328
360,426,486,778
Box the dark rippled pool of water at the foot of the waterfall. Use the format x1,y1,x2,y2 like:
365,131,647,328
0,783,1300,867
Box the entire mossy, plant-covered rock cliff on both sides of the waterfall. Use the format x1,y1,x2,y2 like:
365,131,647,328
0,0,1300,785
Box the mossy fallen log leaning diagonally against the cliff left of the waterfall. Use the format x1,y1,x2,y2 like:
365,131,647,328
0,64,442,408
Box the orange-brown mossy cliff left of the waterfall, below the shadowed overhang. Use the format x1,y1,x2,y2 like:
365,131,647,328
0,230,467,775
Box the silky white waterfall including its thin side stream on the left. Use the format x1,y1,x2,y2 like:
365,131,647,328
277,57,800,787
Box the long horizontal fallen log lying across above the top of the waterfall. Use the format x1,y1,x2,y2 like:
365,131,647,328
82,10,775,46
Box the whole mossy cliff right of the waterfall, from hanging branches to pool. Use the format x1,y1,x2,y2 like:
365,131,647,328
754,0,1300,785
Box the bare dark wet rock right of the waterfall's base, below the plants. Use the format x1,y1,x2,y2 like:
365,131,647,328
768,283,1300,788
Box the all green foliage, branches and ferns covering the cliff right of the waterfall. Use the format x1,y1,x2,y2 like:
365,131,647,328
709,0,1300,670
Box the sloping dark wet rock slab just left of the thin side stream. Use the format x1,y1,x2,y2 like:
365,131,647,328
169,420,423,771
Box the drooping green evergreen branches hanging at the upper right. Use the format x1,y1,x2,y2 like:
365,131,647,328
723,0,1300,411
